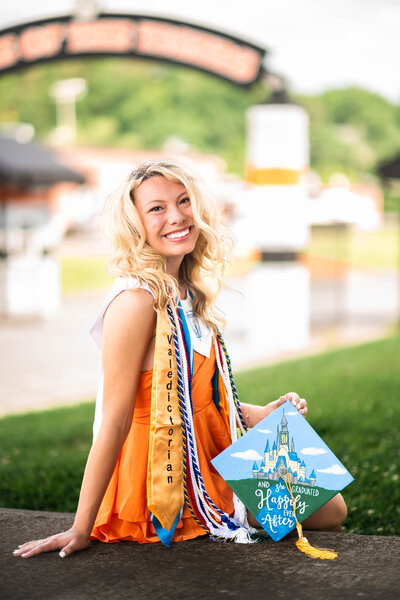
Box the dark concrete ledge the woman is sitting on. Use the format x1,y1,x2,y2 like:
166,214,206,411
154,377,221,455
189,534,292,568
0,509,400,600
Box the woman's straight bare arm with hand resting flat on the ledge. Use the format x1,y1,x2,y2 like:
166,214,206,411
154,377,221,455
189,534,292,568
14,289,156,558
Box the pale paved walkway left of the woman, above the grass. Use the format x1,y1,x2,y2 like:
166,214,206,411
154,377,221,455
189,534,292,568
0,292,105,415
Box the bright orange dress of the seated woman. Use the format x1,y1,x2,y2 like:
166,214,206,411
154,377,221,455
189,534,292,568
90,345,233,543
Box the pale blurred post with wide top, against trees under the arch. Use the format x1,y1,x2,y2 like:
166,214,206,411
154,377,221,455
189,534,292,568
50,77,87,144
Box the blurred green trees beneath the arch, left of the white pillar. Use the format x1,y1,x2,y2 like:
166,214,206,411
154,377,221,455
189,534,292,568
0,58,265,173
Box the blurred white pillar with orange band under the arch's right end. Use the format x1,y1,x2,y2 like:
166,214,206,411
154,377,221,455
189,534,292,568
243,78,310,356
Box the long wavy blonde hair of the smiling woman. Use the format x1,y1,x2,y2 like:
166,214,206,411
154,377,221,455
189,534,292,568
103,160,233,331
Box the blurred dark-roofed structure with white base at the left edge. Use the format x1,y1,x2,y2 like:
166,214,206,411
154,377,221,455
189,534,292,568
0,128,85,316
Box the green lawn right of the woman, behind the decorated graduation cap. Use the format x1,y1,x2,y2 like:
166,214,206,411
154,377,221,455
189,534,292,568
237,337,400,535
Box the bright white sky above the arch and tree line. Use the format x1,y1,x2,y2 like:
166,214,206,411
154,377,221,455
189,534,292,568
0,0,400,103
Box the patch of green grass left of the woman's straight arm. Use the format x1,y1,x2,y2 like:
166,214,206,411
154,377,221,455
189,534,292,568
0,403,94,512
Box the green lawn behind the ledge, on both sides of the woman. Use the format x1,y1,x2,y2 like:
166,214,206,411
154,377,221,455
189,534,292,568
0,336,400,535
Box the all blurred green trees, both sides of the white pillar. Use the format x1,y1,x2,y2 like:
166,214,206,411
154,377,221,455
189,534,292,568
0,57,400,186
